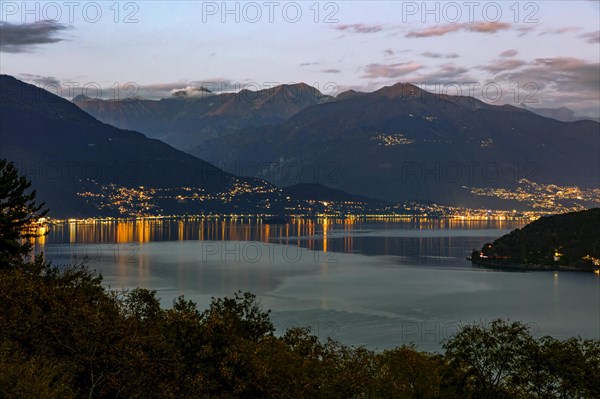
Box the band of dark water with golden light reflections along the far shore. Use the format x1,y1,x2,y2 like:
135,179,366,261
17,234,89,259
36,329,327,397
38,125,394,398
34,218,526,264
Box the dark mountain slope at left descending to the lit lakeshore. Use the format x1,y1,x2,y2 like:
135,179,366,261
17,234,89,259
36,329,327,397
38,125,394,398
0,75,278,217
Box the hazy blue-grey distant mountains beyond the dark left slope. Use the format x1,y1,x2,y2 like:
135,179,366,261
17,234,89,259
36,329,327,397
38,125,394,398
75,79,600,208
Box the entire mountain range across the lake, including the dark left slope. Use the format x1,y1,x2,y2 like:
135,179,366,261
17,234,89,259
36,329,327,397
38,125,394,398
0,75,600,214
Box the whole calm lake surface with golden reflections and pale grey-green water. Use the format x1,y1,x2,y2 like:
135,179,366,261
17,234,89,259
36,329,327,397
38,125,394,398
35,219,600,351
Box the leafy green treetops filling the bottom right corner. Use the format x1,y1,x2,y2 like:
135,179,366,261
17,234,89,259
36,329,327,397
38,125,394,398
442,320,600,398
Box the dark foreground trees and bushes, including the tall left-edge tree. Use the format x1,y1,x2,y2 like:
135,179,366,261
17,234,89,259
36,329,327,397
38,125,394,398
0,161,600,399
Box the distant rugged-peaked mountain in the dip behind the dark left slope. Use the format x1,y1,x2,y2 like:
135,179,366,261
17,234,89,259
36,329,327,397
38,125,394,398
73,83,332,152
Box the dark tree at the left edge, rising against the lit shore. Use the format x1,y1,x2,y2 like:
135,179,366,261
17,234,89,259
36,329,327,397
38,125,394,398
0,159,48,268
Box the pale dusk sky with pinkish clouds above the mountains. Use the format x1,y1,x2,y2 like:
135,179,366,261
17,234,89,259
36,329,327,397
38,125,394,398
0,0,600,118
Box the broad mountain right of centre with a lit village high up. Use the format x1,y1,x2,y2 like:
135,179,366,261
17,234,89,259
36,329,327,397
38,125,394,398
192,83,600,209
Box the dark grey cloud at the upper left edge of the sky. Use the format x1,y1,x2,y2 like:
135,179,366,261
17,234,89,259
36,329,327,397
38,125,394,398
0,21,69,53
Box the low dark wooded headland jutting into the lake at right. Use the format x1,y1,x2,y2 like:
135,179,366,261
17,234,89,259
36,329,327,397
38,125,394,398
471,208,600,269
